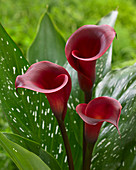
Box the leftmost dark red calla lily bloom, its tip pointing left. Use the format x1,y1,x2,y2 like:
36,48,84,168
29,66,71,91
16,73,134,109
15,61,71,120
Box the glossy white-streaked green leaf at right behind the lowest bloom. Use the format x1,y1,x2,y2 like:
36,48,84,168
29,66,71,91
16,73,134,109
93,66,136,170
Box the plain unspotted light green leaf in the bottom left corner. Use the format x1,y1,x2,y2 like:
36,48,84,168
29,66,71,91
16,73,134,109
0,132,50,170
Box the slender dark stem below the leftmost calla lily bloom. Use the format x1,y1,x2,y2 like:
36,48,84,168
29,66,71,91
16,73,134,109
57,119,74,170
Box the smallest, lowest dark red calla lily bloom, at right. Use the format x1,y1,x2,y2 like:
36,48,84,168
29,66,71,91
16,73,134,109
76,97,122,143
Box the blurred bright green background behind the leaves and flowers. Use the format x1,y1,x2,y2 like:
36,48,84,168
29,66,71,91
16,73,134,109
0,0,136,170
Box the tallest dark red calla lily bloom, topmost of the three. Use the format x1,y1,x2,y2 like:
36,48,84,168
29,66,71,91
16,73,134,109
65,25,116,97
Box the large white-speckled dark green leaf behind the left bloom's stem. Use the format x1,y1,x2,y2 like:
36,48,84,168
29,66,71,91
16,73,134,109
0,22,81,169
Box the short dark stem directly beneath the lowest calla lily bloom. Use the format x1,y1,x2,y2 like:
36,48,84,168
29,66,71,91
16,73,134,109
83,142,95,170
